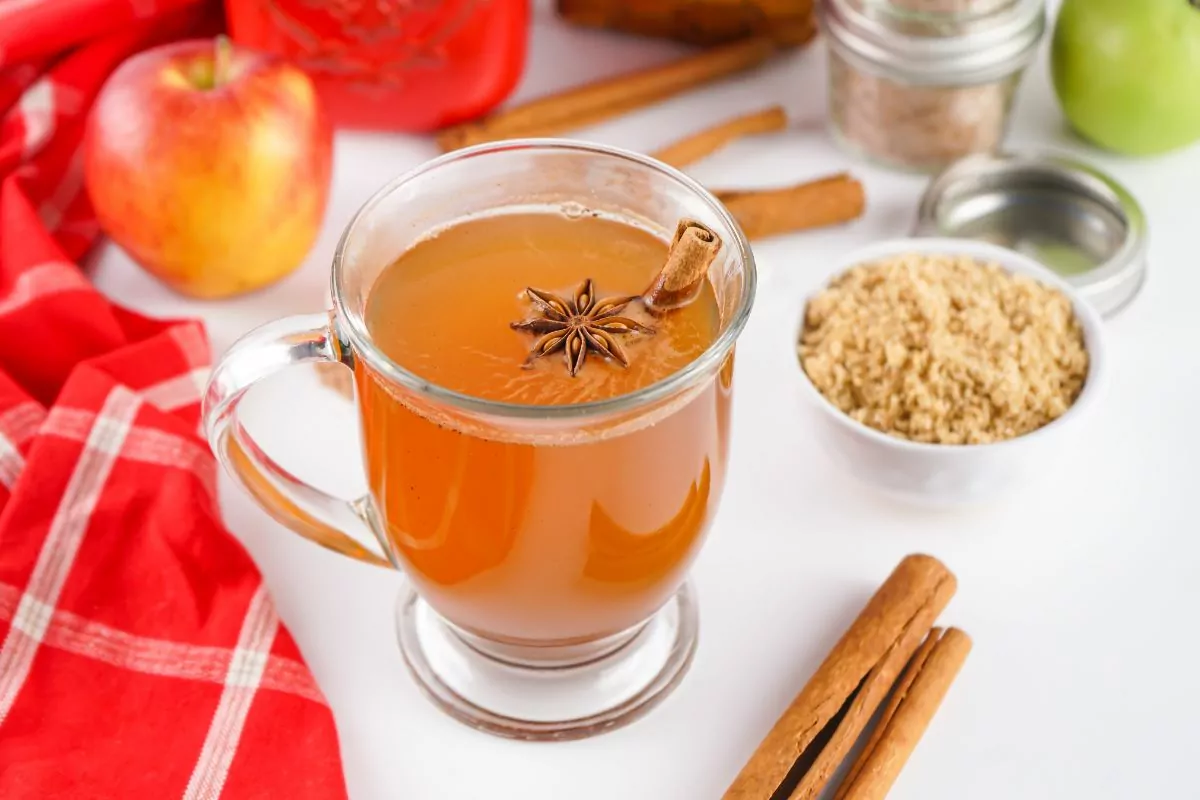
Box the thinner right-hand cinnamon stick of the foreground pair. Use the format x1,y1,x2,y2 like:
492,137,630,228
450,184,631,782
834,627,971,800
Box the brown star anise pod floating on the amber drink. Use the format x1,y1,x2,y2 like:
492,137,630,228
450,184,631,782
512,278,654,377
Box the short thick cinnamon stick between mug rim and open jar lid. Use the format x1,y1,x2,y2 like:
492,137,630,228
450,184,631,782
714,173,866,240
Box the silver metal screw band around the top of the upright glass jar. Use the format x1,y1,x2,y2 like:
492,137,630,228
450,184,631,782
817,0,1046,86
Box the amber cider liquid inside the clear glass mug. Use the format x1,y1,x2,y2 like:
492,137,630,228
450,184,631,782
358,211,730,644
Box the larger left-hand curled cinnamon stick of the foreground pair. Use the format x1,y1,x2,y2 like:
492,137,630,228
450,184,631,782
724,555,956,800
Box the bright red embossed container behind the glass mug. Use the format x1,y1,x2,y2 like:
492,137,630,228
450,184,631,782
226,0,529,131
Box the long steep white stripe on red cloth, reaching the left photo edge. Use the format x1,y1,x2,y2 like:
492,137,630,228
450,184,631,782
0,386,139,724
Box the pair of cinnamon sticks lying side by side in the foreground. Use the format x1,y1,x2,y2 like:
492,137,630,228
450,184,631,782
724,555,971,800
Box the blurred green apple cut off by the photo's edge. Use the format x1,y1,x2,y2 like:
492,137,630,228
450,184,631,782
1050,0,1200,155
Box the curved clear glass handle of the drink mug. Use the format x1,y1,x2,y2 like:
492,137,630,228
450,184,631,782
202,314,396,567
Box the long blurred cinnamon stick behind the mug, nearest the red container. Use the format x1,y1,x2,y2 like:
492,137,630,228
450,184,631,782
438,36,776,151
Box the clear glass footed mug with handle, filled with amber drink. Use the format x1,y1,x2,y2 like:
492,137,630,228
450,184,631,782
205,140,754,739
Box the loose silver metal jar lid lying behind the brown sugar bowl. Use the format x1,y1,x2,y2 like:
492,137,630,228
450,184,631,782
914,155,1147,317
